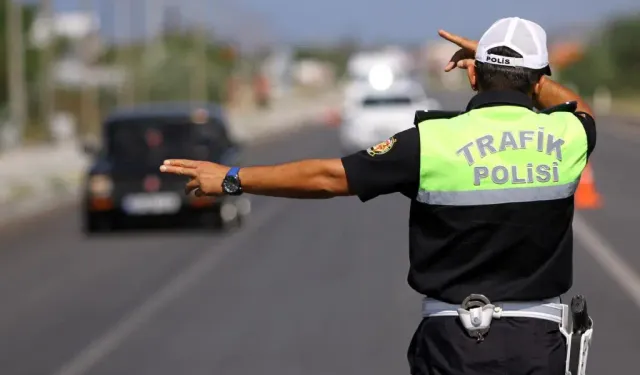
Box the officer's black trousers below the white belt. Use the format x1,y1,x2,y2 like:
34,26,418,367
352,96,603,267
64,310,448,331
407,317,567,375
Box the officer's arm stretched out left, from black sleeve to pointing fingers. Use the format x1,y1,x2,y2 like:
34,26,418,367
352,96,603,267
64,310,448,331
160,128,420,201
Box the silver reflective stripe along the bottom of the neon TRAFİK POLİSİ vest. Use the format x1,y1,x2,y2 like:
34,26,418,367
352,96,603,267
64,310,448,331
417,180,579,206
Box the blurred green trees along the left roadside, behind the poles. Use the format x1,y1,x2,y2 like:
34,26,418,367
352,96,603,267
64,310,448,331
0,0,239,140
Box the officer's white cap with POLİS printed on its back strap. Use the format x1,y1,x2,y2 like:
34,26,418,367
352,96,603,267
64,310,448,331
476,17,551,75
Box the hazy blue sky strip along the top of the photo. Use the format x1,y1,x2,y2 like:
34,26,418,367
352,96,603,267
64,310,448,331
48,0,640,43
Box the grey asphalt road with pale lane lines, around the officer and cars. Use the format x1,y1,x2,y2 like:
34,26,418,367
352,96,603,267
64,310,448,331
0,92,640,375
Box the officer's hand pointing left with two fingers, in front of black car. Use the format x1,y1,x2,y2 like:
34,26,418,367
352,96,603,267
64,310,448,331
160,159,229,197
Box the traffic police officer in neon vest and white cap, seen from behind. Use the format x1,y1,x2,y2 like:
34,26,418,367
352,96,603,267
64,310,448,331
160,18,596,375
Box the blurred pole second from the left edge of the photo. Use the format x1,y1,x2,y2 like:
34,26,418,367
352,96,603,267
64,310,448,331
38,0,56,140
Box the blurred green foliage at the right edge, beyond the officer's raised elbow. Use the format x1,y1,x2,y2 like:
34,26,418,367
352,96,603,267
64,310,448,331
562,14,640,96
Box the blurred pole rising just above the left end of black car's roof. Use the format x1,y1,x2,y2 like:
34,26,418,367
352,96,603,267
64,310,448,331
114,0,135,106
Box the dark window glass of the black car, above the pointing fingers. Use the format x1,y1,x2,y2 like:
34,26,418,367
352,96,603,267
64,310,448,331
107,118,220,170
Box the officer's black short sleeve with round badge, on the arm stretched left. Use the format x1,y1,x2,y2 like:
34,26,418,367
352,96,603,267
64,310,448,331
342,128,420,202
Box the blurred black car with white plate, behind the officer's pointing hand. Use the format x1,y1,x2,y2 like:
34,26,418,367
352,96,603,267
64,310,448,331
82,104,250,233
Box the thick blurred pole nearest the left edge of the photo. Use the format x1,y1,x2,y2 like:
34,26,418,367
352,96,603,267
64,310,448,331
5,0,27,147
